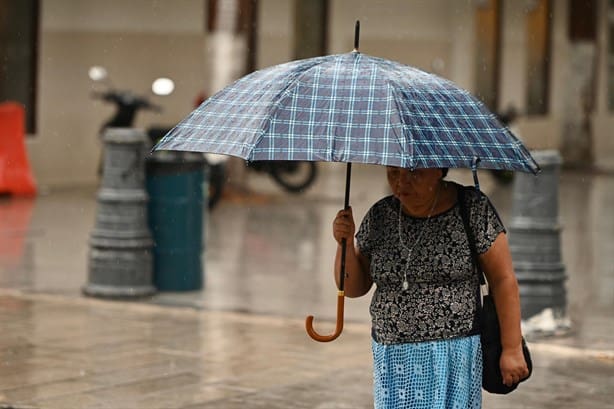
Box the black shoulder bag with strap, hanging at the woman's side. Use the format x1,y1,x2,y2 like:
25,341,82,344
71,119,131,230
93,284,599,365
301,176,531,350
458,187,533,395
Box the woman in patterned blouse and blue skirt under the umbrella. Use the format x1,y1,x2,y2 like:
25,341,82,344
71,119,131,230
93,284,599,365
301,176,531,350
333,167,528,409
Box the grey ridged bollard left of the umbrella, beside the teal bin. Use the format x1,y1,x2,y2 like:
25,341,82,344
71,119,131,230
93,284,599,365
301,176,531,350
83,128,155,297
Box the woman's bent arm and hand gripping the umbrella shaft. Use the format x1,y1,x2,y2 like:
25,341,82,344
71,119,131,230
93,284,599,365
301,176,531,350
333,208,373,298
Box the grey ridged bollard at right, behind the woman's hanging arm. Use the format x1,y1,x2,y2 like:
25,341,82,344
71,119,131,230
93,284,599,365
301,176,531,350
509,150,567,325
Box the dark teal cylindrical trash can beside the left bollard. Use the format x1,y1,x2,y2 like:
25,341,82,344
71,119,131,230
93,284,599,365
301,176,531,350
146,151,208,291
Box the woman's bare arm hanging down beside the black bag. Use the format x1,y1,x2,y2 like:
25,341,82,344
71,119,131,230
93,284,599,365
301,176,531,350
479,233,529,386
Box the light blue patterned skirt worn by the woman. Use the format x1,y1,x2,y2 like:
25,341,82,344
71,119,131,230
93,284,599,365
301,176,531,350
372,335,482,409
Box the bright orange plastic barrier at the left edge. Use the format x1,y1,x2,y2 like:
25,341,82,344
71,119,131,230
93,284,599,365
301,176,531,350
0,102,36,196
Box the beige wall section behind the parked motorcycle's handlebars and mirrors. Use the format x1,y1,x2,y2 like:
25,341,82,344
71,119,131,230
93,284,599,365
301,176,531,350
28,0,206,188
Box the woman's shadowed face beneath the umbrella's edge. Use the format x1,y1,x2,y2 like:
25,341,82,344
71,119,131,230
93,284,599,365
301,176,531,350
386,166,443,204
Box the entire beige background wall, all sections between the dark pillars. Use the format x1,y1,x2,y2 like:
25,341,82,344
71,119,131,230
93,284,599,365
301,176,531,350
28,0,614,186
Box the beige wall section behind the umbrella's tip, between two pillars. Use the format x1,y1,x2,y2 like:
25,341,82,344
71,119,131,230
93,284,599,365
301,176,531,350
329,0,473,83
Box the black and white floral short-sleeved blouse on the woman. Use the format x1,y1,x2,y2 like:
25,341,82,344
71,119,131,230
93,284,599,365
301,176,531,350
356,185,505,344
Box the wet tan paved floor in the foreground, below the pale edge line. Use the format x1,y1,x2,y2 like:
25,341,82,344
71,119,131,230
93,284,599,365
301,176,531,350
0,290,614,409
